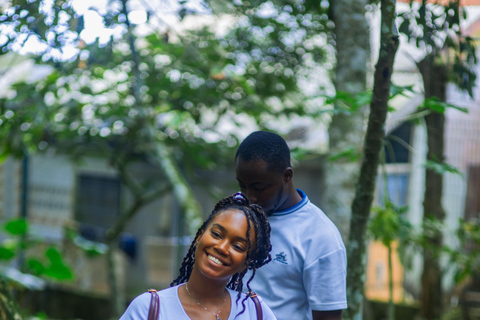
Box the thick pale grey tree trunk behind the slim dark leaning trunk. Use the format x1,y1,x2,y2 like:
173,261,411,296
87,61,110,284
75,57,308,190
321,0,370,240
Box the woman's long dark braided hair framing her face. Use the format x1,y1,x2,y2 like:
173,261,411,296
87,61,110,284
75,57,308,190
170,192,272,314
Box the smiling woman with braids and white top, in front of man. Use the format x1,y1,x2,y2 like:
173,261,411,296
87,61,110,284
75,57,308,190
120,193,276,320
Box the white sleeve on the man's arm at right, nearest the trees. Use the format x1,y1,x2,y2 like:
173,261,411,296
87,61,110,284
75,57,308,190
303,248,347,311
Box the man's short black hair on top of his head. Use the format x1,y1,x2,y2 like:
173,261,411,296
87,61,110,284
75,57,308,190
235,131,291,172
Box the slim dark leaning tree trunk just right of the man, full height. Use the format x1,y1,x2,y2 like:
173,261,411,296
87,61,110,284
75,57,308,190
347,0,399,320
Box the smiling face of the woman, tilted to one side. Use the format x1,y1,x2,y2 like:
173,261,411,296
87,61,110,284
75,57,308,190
194,208,255,280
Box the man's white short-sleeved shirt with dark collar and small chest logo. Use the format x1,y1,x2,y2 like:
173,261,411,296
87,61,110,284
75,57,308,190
244,189,347,320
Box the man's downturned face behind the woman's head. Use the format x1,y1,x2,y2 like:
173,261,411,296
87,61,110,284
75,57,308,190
235,157,287,215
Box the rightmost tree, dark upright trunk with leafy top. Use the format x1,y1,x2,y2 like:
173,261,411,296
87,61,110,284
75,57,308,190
400,0,476,319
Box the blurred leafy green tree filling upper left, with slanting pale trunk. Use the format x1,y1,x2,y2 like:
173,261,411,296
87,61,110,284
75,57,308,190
0,0,334,315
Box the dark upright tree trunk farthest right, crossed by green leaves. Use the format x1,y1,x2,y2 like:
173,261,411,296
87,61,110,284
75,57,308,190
418,56,447,320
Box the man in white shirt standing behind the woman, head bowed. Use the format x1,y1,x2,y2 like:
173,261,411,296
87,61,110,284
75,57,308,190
235,131,347,320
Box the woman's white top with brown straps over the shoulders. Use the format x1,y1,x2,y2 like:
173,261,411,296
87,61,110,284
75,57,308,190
120,284,277,320
